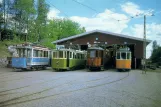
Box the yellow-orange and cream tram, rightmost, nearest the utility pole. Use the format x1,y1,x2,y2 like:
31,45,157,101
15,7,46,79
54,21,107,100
116,47,131,71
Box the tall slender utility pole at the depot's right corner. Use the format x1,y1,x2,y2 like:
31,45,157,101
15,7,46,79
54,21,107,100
143,15,146,73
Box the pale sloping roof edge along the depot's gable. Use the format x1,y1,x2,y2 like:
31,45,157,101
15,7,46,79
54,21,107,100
52,30,151,44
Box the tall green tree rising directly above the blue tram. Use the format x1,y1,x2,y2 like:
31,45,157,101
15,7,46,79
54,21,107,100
15,0,36,41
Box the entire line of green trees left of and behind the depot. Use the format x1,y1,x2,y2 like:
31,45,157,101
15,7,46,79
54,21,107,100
0,0,85,47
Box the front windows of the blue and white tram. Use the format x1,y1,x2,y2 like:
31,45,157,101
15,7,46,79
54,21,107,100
17,48,31,57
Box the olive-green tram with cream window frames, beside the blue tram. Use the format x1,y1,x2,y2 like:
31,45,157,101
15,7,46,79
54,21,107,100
51,49,86,70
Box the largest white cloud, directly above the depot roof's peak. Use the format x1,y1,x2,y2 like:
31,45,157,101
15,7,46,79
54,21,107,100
70,9,129,33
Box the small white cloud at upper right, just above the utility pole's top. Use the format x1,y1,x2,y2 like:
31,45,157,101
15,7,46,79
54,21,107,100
121,2,144,16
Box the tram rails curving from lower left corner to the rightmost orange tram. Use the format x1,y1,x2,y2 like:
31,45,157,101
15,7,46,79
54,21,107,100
0,72,129,107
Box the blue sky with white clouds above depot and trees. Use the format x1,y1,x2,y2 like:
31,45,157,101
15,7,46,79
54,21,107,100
46,0,161,57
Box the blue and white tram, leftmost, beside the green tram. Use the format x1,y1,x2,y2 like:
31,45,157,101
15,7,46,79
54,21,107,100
12,45,51,70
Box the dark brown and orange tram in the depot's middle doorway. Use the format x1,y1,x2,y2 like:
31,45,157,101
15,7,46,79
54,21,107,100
87,46,104,70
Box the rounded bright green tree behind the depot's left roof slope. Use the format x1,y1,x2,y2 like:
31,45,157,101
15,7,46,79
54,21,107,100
39,19,85,47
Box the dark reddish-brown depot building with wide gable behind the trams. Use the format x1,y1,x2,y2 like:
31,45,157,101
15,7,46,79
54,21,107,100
52,30,151,69
